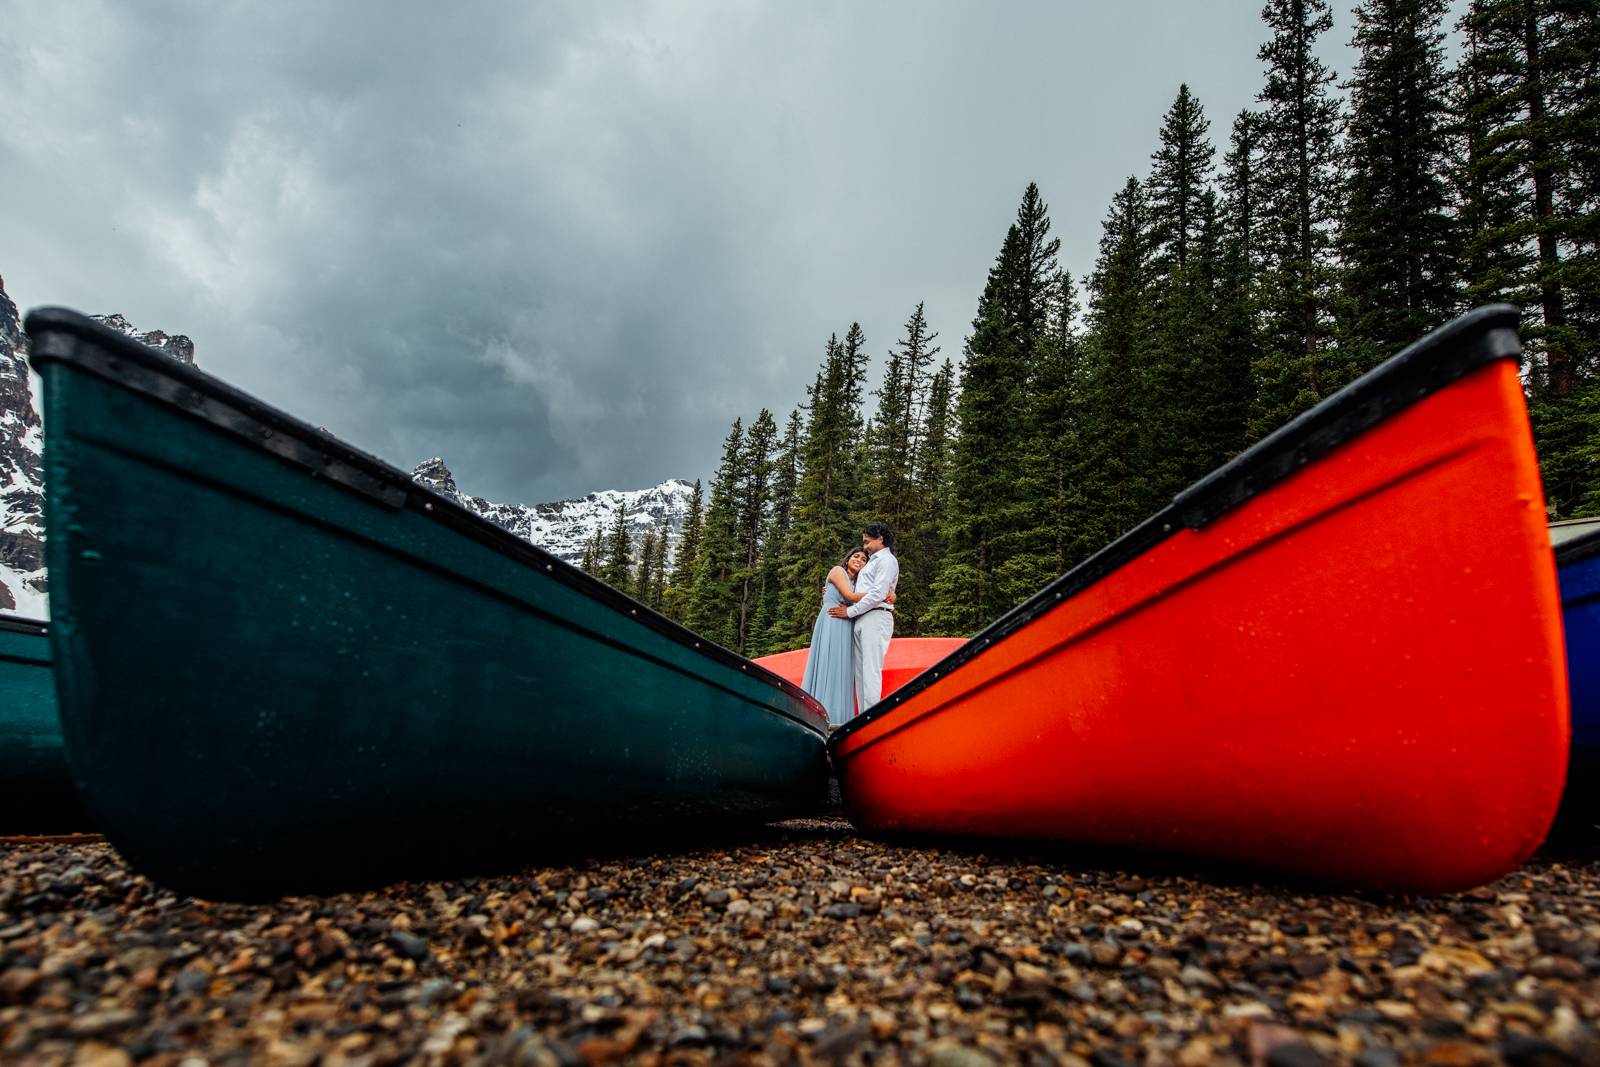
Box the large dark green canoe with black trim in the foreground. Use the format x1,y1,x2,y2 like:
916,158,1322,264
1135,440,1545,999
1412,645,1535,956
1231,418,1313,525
26,309,827,899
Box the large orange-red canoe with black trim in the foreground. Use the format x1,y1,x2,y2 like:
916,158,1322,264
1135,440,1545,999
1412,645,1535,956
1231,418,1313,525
830,307,1568,891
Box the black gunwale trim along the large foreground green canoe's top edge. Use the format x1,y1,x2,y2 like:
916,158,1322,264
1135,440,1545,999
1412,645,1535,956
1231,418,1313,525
22,307,827,737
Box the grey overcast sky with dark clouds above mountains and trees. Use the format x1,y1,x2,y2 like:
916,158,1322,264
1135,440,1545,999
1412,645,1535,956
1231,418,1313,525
0,0,1459,502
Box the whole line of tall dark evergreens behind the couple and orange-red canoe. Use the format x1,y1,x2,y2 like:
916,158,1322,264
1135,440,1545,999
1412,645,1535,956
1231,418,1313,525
584,0,1600,656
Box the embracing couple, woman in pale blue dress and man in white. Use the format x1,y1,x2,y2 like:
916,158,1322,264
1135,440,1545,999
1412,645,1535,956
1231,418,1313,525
800,523,899,726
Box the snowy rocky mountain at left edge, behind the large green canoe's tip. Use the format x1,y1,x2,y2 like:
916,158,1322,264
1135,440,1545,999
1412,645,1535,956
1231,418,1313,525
0,278,195,619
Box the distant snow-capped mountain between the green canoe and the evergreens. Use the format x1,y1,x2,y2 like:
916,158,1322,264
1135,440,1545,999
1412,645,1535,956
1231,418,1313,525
411,458,694,565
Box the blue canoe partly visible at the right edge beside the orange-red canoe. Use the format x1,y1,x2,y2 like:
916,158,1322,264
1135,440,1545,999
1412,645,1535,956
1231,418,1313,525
1550,518,1600,825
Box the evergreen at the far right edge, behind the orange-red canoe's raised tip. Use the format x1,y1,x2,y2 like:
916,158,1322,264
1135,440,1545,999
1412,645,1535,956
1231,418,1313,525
1462,0,1600,517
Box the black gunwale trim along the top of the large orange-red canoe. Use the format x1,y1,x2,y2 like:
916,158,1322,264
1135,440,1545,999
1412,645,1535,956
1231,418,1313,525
829,304,1522,753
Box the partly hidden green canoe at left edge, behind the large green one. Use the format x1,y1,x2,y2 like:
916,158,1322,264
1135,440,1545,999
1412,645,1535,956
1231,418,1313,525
0,614,93,833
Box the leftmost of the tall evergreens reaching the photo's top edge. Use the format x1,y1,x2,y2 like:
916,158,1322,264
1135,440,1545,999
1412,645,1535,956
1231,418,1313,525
1251,0,1352,435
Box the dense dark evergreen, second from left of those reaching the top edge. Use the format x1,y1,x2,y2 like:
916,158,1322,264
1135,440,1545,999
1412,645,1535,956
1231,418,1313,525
1339,0,1461,373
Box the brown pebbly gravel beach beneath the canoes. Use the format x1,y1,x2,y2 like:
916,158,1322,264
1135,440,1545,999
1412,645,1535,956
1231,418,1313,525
0,819,1600,1067
